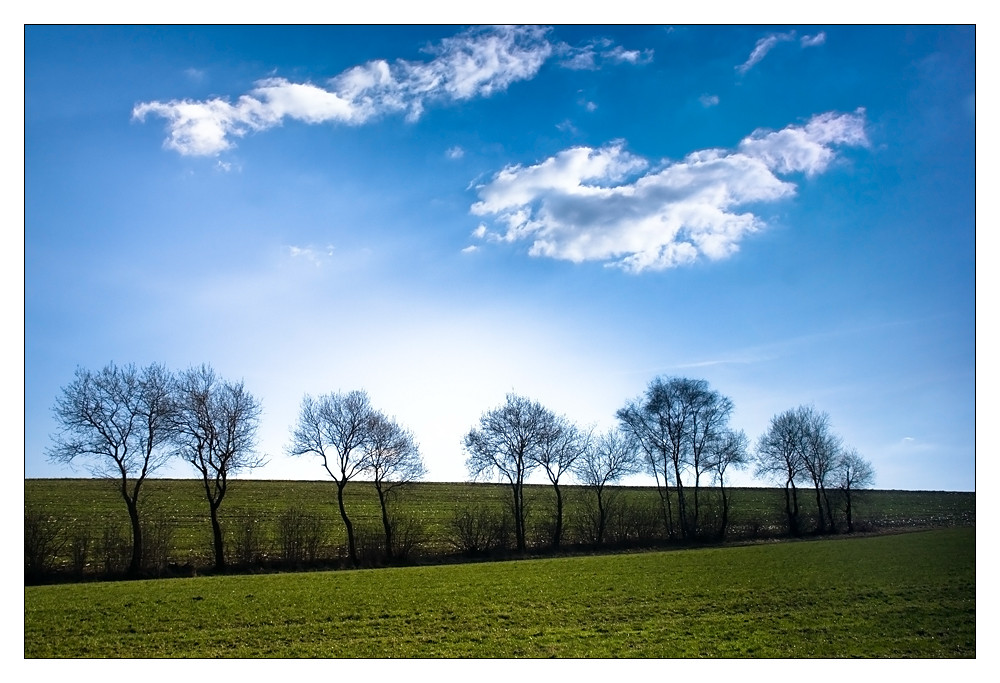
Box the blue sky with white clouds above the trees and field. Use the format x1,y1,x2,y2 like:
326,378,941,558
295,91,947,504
24,25,976,490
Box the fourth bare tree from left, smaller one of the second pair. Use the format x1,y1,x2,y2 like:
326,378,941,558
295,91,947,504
364,411,427,560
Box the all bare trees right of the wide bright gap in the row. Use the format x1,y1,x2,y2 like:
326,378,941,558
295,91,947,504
464,377,874,551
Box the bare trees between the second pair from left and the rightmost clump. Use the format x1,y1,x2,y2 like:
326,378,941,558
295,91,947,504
465,378,749,550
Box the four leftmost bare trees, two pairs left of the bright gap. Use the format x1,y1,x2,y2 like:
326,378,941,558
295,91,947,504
48,363,425,575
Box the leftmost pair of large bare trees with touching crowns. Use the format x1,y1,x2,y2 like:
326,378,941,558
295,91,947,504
48,363,263,575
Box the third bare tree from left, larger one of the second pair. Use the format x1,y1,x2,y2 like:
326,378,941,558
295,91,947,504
288,391,372,566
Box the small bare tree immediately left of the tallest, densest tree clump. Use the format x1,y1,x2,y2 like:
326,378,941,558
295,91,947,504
573,428,641,545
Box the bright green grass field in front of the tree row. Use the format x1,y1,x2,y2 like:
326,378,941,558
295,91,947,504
24,528,976,658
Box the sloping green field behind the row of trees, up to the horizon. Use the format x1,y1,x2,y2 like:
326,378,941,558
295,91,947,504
24,479,976,566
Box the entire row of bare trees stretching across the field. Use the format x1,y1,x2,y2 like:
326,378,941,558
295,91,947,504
35,363,874,575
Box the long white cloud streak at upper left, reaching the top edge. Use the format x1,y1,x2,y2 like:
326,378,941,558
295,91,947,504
132,26,648,156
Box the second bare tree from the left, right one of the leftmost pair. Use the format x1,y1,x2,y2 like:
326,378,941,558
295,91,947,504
172,365,264,569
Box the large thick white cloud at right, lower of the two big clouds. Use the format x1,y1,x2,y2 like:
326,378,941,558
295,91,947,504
471,110,868,273
